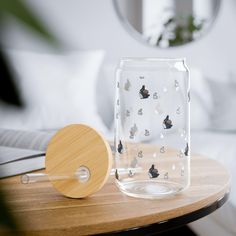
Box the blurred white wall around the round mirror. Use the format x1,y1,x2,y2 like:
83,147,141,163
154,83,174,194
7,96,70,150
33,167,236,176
1,0,236,78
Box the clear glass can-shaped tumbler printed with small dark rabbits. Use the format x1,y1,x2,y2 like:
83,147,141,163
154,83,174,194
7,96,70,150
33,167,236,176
115,58,190,199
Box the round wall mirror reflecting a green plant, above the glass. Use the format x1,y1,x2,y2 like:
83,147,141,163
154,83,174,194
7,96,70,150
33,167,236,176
113,0,220,48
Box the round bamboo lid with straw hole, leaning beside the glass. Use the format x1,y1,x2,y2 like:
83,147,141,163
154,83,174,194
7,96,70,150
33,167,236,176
45,124,112,198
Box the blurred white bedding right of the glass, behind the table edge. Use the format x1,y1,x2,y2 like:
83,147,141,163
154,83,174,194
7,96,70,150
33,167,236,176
191,131,236,236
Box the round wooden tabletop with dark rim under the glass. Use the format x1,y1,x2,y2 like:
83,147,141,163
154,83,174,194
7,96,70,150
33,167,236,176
0,156,230,236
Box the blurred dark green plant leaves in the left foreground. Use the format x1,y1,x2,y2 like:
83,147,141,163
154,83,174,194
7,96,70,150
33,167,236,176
0,0,59,232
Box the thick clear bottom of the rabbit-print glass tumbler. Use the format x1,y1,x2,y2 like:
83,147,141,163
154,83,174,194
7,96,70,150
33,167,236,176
117,180,184,199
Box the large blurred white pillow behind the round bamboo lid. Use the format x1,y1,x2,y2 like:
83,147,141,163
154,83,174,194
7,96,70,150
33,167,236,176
0,50,108,135
